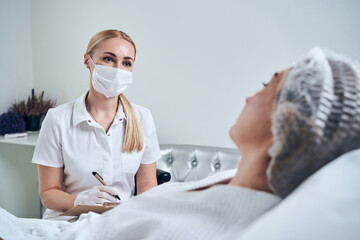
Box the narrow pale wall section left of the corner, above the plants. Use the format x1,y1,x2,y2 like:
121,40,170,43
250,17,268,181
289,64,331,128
0,0,33,114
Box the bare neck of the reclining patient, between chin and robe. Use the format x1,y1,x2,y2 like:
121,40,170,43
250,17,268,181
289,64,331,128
229,146,271,192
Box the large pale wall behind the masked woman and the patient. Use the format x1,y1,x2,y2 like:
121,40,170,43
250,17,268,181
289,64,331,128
0,0,360,147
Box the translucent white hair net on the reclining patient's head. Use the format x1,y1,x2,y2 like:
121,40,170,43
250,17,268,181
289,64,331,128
267,47,360,197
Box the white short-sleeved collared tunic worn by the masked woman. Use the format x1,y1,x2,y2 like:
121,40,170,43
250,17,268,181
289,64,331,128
32,94,161,218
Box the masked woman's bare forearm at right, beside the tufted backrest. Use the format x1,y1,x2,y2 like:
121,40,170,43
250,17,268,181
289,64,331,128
136,162,157,194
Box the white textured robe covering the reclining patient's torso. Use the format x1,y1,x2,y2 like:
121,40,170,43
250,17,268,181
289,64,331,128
59,170,280,240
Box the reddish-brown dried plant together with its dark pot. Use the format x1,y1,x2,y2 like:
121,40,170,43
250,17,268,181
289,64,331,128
9,89,56,131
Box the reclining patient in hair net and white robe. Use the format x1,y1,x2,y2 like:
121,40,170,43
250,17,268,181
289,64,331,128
0,48,360,239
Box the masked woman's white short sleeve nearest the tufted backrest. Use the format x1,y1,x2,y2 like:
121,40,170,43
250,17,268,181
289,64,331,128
141,112,161,164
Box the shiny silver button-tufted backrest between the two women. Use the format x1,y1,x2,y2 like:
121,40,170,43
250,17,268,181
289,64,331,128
157,144,240,182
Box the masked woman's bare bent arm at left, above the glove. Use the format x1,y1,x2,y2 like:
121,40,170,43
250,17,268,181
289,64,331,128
38,164,76,212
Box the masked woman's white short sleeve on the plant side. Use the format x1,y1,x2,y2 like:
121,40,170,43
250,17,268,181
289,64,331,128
32,109,64,168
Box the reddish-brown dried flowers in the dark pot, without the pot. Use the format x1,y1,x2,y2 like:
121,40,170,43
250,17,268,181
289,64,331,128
9,89,56,117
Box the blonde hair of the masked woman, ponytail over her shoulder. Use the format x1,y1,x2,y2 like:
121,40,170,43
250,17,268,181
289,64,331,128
86,29,143,153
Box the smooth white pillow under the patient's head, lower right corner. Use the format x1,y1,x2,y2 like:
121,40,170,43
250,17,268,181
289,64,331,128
238,149,360,240
